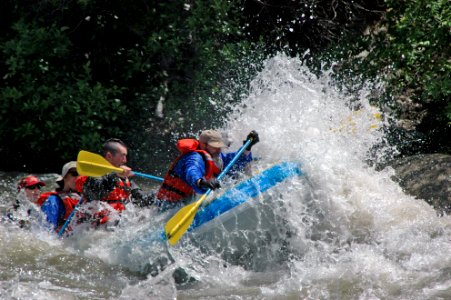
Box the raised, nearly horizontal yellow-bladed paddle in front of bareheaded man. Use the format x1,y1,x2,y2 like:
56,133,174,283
77,150,163,182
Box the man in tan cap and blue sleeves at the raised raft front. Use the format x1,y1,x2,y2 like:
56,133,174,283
156,130,259,208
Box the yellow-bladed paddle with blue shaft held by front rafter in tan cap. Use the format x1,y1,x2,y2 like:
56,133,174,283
165,139,252,246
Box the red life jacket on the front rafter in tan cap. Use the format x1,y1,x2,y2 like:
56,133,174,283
157,139,221,202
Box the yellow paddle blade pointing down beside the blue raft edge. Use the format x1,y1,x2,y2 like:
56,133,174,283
164,194,207,246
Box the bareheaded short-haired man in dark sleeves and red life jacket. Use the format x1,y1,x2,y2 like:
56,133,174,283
77,138,154,225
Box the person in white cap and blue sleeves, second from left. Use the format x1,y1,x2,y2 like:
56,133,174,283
38,161,81,231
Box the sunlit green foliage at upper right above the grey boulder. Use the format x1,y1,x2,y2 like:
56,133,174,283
316,0,451,154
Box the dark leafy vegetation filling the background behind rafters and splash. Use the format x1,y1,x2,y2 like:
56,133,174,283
0,0,451,172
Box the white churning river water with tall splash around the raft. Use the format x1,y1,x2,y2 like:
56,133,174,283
0,55,451,299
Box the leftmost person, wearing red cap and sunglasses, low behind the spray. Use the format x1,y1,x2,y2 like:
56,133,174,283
6,175,45,228
